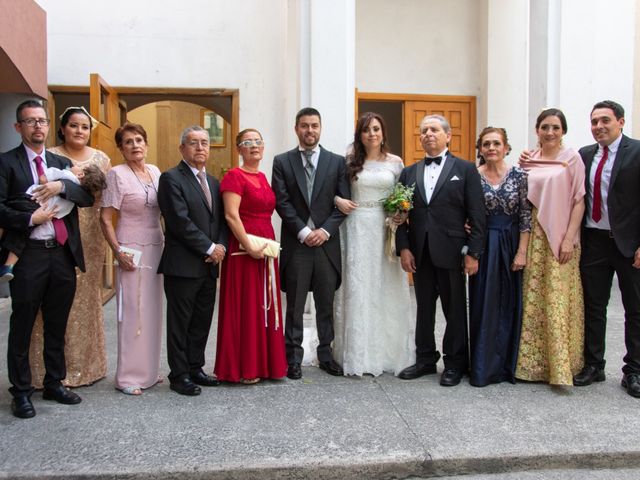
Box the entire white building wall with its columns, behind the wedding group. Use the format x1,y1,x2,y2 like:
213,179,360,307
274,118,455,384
28,0,638,163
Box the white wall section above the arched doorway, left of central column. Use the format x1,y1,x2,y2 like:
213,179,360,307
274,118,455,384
37,0,295,176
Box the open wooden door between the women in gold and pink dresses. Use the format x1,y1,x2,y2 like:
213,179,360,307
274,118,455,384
89,73,126,301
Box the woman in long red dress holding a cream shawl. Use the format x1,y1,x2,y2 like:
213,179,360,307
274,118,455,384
214,128,287,384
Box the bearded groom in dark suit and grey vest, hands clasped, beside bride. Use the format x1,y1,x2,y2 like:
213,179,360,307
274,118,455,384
272,108,350,379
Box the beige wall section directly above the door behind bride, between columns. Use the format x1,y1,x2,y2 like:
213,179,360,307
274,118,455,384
356,0,485,95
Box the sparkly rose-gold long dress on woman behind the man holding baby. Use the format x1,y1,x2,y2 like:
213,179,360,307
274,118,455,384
29,147,111,388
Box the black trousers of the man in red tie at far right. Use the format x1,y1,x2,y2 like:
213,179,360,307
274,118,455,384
580,228,640,373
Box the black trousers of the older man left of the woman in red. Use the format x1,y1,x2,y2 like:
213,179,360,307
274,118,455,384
164,275,217,382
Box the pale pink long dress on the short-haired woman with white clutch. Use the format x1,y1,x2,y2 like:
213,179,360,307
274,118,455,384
102,164,164,389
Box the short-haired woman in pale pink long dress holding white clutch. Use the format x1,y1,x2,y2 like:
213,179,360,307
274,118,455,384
100,123,164,395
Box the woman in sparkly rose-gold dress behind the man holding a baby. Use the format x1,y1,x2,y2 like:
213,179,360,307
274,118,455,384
29,107,111,388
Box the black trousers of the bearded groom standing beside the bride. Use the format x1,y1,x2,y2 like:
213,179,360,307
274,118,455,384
284,244,338,364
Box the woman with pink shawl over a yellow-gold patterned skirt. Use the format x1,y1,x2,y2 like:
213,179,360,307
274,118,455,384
516,108,585,385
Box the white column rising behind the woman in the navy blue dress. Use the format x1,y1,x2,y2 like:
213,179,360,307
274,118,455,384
478,0,528,156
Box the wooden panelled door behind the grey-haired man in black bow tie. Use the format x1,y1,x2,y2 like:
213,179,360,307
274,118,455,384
404,98,476,165
